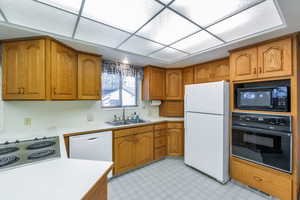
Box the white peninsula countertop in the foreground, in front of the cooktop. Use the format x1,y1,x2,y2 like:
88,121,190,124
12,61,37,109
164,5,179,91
0,158,112,200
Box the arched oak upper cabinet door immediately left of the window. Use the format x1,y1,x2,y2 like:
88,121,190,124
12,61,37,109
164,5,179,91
78,54,101,100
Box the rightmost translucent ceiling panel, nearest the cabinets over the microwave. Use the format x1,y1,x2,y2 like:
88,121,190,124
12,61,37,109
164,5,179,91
208,0,283,41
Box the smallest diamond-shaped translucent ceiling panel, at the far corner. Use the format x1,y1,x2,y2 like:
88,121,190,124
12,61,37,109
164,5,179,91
150,47,188,62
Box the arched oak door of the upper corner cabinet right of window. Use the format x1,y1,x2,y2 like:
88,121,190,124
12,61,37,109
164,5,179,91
166,69,183,100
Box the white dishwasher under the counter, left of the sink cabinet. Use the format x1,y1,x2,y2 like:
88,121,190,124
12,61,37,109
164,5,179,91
70,131,113,177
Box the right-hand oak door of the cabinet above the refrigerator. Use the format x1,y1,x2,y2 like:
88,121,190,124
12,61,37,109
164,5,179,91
211,59,229,81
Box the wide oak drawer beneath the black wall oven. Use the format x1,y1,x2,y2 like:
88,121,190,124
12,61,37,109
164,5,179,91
231,159,292,200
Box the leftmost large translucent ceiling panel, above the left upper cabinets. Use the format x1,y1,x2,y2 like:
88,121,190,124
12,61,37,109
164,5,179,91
0,0,77,36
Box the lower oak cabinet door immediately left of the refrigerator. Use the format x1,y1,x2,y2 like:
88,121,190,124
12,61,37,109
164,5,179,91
167,123,184,156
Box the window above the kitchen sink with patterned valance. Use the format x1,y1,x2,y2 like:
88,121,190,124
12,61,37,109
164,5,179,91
102,72,138,108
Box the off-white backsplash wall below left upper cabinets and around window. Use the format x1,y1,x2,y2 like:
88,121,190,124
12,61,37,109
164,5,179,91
0,52,159,136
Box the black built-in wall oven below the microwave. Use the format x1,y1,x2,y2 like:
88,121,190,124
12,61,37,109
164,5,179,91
232,113,292,173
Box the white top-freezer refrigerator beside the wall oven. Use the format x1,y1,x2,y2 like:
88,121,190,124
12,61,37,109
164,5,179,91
184,81,229,183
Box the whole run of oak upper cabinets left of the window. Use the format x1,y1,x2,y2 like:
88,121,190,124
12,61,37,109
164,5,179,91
2,37,101,100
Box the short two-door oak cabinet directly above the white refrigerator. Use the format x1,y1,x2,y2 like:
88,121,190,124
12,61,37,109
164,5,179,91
194,58,229,83
